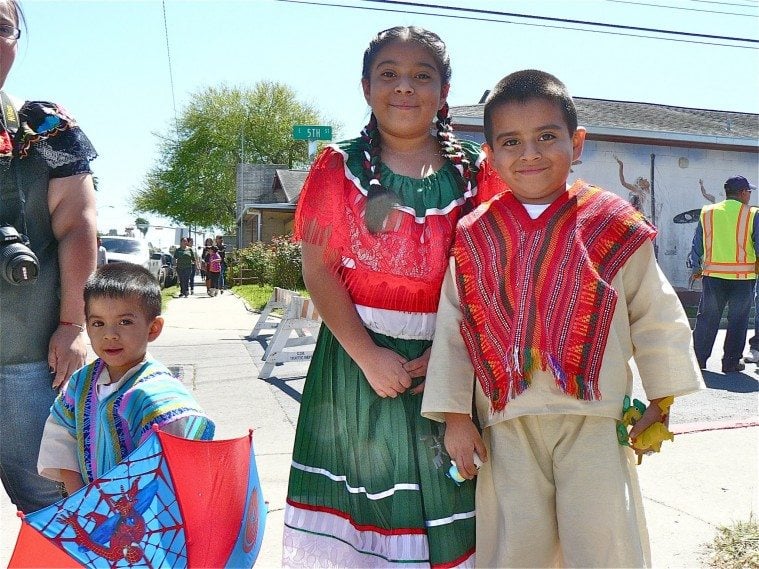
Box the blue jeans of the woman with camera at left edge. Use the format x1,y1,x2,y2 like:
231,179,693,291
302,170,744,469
0,362,62,513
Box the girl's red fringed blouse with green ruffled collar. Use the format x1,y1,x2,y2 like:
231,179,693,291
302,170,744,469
295,139,490,312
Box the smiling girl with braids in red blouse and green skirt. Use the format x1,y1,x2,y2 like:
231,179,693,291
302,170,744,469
283,23,497,567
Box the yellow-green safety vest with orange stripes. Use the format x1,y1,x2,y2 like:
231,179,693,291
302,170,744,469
701,199,757,280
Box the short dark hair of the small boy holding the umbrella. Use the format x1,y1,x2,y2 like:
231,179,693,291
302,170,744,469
84,263,161,320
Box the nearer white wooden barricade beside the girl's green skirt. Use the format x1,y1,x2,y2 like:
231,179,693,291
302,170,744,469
258,294,322,379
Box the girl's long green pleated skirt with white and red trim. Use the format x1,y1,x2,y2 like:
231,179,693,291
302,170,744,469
283,326,475,568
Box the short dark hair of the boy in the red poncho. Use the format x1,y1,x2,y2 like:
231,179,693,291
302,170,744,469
483,69,577,146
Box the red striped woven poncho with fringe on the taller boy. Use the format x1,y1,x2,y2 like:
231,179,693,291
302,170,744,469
452,180,656,411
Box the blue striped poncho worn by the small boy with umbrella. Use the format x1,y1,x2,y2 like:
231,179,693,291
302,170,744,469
50,358,215,484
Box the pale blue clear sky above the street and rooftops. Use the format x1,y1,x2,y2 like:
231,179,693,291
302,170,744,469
5,0,759,235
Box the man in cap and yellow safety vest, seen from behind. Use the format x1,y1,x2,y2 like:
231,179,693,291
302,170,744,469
688,176,759,373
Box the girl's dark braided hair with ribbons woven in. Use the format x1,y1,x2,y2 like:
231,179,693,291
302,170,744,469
361,26,472,233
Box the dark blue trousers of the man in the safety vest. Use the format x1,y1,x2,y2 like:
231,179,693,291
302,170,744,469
693,277,755,367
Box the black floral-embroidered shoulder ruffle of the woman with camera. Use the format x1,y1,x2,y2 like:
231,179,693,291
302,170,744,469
0,101,97,174
